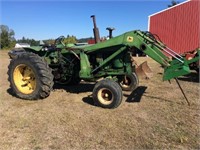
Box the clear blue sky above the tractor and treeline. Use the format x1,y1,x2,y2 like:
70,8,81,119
0,0,185,40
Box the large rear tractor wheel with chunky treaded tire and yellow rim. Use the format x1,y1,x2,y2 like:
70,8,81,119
8,52,53,100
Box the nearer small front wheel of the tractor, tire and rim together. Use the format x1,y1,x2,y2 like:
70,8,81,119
93,79,122,108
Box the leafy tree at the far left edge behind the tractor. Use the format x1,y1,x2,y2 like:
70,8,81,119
0,25,16,49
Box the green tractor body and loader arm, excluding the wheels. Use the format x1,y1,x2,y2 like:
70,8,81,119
18,30,200,81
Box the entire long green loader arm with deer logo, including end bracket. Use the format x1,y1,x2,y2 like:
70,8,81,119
84,30,200,81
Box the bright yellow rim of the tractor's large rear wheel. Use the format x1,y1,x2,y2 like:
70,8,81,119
13,64,36,94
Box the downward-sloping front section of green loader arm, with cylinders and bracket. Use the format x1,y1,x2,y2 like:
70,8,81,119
130,31,200,81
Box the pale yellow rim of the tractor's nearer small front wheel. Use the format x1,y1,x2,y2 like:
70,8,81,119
97,88,114,105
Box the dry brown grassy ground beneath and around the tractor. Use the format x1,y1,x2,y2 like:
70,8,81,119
0,51,200,150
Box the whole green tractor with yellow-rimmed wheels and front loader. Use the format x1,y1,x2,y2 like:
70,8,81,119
8,15,199,108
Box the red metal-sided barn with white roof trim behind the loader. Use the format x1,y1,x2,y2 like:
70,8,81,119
149,0,200,54
